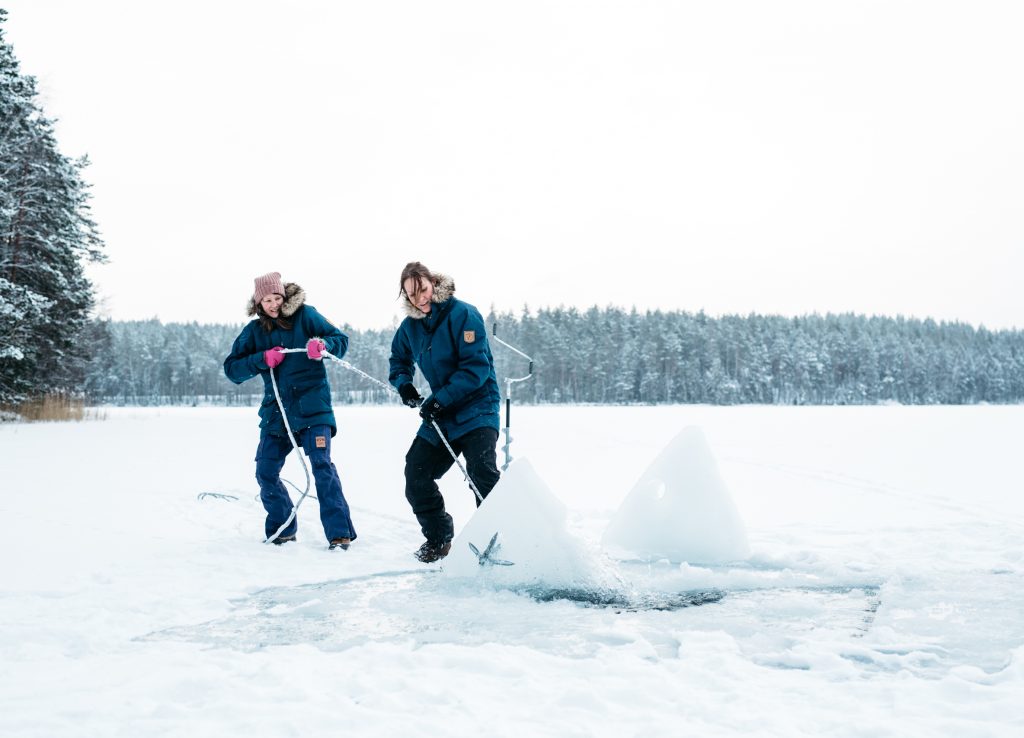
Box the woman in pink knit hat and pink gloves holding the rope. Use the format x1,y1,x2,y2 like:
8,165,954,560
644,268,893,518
224,271,355,550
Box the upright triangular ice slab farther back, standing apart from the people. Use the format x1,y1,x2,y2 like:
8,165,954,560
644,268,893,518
601,426,750,563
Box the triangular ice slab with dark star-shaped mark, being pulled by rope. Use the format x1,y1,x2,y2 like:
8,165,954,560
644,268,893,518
443,459,601,588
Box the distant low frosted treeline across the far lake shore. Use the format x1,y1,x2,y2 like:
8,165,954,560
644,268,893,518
85,307,1024,404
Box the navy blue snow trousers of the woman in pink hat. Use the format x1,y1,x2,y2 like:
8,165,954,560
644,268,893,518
256,425,355,540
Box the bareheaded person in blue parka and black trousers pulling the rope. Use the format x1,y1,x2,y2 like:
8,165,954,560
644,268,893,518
389,261,501,562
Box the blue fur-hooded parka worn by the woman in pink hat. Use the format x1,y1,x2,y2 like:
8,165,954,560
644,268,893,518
224,284,348,437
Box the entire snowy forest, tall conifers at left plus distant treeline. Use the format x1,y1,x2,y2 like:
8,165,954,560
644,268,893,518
0,5,1024,405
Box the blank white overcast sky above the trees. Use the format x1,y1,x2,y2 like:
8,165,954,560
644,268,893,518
0,0,1024,329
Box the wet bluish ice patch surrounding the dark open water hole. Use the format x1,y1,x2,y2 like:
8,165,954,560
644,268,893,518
138,569,878,658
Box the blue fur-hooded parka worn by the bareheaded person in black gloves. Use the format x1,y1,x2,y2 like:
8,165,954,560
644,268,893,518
388,275,501,445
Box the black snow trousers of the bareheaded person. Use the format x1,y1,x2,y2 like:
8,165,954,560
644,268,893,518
406,428,501,545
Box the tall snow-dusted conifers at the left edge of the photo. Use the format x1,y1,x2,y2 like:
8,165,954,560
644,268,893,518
0,9,102,404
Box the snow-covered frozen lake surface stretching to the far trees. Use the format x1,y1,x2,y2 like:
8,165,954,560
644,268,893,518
0,406,1024,738
